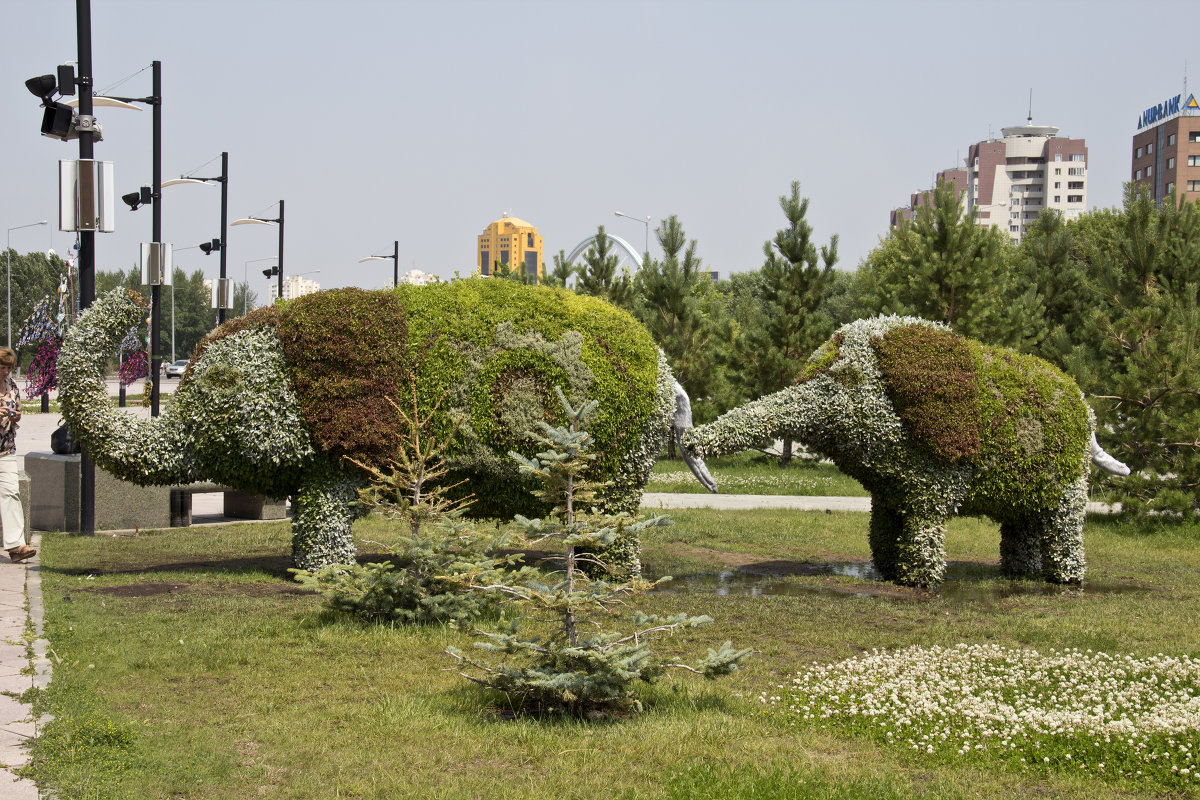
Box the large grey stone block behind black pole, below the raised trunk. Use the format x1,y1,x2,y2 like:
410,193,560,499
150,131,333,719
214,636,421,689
25,452,170,533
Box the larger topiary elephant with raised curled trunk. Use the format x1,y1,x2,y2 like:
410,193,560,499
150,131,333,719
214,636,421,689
59,279,706,570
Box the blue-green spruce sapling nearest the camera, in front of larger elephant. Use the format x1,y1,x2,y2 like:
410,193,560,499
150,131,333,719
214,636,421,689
446,387,751,716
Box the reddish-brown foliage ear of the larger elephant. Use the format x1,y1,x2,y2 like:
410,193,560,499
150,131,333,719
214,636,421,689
278,288,413,465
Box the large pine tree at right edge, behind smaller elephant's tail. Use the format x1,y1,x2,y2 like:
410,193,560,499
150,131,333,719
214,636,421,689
1068,188,1200,518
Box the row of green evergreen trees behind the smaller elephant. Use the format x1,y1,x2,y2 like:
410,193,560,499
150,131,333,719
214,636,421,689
525,184,1200,515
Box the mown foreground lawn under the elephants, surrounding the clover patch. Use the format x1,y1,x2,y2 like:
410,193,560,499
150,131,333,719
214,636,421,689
25,510,1200,800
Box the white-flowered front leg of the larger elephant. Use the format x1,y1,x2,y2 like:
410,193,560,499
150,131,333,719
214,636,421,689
292,471,358,570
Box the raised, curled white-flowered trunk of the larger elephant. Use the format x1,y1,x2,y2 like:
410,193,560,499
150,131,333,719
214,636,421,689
58,289,198,486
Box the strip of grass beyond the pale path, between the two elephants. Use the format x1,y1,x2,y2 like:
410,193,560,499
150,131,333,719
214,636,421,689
646,452,866,497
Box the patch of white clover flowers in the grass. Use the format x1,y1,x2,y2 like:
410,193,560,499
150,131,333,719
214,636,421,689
758,644,1200,786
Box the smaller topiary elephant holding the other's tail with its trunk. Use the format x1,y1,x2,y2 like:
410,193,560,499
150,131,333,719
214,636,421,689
682,317,1129,587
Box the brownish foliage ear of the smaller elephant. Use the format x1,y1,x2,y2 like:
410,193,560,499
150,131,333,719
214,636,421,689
871,324,980,464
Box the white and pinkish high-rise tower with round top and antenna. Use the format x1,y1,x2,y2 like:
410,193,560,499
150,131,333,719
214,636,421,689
967,120,1087,241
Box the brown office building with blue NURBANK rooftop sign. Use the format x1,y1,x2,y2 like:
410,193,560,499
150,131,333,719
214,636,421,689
1129,94,1200,203
